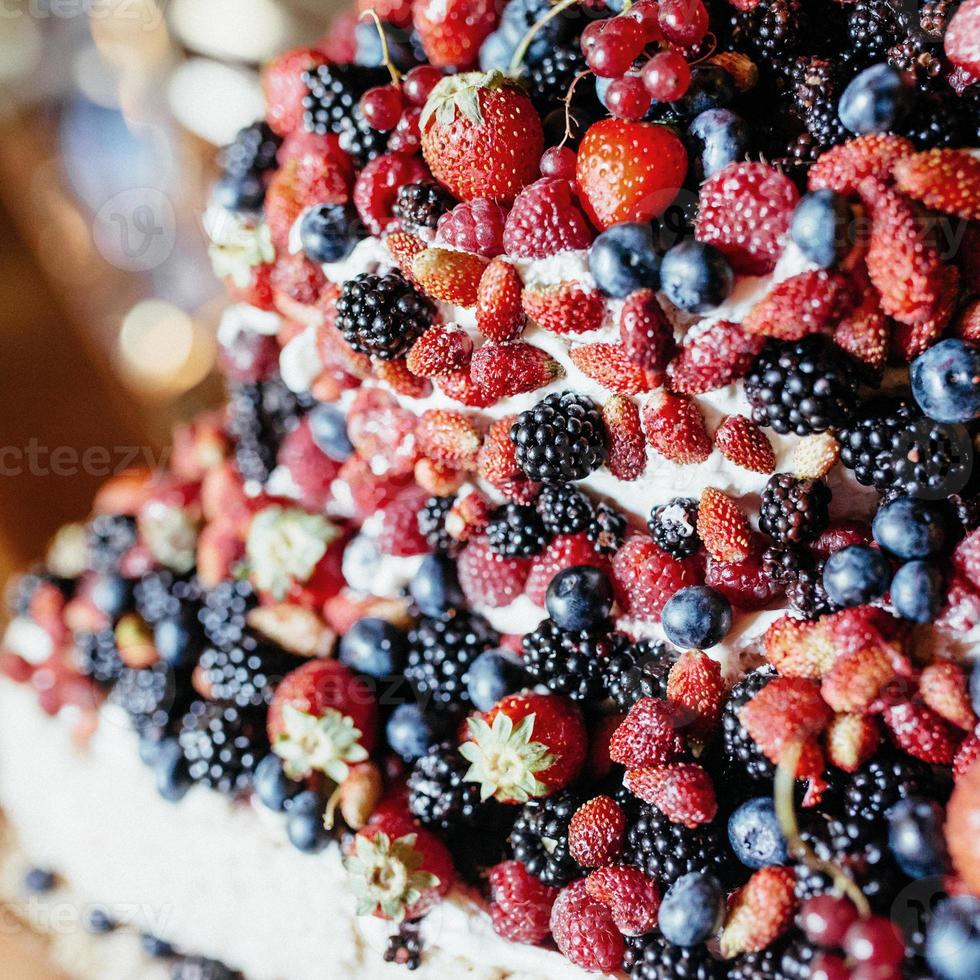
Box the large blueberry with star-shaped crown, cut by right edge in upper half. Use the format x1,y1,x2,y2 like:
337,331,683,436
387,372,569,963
911,339,980,422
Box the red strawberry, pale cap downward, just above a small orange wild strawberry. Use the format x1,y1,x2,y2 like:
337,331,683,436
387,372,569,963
267,660,378,783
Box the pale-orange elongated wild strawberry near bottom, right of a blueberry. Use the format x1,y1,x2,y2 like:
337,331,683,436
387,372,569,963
721,865,796,959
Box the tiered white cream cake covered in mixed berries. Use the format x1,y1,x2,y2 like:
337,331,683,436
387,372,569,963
0,0,980,980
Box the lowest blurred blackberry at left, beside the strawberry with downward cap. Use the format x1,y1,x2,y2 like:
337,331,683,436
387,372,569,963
177,701,269,794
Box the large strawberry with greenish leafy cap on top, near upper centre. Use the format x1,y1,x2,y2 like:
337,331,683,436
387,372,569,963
420,72,544,204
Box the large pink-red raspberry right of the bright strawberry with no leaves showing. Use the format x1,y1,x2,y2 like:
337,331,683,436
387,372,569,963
695,163,800,275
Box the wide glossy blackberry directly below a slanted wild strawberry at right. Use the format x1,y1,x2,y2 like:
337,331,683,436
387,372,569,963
745,334,858,436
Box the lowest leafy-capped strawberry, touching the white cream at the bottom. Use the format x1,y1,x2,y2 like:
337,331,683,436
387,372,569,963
344,812,455,922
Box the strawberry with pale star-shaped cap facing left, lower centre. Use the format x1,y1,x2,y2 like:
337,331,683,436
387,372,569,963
459,693,588,803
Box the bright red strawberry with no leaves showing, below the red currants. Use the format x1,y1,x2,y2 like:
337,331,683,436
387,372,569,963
575,119,687,229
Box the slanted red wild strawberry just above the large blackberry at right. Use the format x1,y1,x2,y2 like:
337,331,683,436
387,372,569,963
742,269,852,340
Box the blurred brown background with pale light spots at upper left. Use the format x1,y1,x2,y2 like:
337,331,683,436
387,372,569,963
0,0,341,581
